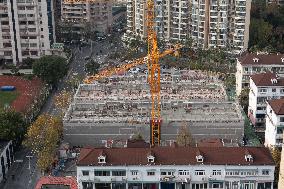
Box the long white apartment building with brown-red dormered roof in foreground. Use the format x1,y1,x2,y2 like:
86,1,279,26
77,147,274,189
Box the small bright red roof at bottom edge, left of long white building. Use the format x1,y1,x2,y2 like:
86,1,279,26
35,176,78,189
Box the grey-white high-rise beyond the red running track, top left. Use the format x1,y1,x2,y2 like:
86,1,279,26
0,0,55,64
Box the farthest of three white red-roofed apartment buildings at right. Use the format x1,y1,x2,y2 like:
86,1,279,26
236,53,284,95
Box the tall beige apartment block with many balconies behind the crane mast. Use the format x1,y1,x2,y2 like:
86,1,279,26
127,0,251,54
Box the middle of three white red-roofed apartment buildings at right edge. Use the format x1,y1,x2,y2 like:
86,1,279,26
248,72,284,132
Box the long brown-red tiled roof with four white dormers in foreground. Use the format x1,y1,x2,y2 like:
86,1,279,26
77,147,274,166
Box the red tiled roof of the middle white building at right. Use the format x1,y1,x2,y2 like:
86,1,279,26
251,72,284,86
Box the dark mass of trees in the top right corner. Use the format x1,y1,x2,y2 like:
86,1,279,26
249,0,284,53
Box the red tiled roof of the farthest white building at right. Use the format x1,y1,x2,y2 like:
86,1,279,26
238,53,284,65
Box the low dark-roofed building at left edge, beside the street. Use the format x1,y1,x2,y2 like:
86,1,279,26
0,140,14,182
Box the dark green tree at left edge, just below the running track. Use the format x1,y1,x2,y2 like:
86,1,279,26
0,109,27,145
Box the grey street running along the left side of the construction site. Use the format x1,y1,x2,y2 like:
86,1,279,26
0,34,119,189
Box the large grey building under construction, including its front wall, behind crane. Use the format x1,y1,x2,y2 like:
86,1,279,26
63,70,244,146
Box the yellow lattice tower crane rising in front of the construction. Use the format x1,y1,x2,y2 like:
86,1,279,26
64,0,182,146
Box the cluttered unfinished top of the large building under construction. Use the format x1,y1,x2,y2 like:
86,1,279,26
64,70,240,123
